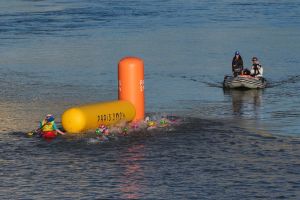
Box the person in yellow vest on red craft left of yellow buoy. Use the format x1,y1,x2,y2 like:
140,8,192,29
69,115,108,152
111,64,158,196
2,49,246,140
39,114,65,137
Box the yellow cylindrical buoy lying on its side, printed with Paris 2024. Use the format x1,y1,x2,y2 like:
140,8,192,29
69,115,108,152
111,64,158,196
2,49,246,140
62,101,135,133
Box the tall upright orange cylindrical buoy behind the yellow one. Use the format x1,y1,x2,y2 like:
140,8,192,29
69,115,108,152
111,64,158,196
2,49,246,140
118,57,145,121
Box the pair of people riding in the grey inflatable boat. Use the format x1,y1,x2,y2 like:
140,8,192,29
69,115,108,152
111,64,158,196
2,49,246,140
232,51,263,77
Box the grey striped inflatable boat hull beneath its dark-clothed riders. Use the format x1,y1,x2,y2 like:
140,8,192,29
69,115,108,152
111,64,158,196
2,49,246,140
223,75,267,89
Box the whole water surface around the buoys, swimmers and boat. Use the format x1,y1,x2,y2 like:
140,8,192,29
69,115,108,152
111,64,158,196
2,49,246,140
0,0,300,199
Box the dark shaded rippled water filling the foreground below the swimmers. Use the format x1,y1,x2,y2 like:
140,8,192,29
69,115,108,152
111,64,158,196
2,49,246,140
4,117,300,199
